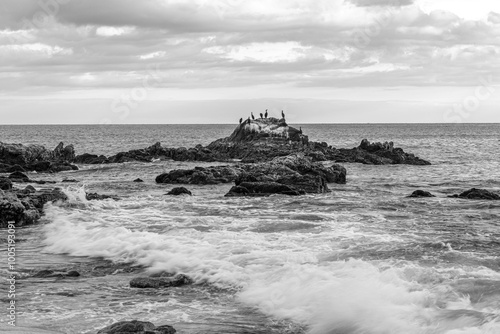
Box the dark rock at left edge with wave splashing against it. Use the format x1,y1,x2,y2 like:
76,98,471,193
0,187,68,227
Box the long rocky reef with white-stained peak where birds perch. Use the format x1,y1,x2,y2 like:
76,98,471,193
63,117,430,165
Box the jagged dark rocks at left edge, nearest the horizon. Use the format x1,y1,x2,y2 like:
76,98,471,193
0,142,78,173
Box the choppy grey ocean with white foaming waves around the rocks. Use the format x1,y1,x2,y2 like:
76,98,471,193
0,124,500,334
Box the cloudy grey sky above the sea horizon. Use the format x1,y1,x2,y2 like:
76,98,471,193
0,0,500,124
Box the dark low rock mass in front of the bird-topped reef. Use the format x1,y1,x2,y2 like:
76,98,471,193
156,154,347,196
